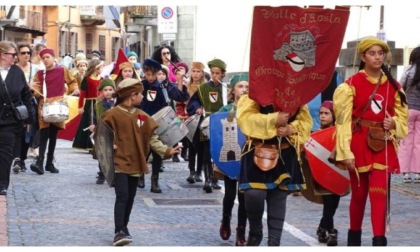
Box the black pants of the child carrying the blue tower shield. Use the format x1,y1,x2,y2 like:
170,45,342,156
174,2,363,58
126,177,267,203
223,176,246,227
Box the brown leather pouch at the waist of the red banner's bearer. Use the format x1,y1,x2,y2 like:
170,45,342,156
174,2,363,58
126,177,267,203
254,144,280,171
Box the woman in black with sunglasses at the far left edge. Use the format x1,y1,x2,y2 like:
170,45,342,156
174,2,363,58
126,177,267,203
0,41,35,195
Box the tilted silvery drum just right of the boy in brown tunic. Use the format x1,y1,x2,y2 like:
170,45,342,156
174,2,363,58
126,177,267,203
152,106,188,146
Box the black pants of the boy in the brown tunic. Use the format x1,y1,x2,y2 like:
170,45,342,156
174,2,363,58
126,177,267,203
114,173,139,233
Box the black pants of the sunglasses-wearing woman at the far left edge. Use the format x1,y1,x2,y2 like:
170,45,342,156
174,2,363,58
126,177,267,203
0,123,23,190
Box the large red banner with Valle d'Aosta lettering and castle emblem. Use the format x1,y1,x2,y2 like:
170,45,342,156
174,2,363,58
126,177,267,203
249,6,350,113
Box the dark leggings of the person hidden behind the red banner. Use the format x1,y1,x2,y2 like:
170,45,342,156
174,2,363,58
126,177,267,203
245,189,288,246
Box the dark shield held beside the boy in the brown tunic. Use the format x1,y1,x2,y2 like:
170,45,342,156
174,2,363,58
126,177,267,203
93,119,115,187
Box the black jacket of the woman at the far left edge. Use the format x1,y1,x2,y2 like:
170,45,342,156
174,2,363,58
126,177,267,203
0,65,35,125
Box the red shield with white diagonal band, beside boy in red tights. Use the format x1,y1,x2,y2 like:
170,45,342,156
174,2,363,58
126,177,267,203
305,126,350,195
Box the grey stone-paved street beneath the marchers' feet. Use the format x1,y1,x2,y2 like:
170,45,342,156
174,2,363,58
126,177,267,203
0,140,420,247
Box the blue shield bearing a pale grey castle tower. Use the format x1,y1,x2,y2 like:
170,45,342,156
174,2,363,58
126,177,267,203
210,112,246,179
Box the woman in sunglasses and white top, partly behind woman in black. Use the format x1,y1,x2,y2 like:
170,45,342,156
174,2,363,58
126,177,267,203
12,44,39,173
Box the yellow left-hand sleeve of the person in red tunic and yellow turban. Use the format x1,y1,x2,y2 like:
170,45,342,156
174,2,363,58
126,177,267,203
333,83,354,161
